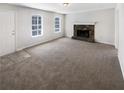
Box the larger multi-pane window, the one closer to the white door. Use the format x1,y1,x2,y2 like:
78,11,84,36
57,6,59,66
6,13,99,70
32,16,43,36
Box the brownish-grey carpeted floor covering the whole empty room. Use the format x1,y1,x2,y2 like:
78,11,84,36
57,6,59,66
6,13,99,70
0,38,124,90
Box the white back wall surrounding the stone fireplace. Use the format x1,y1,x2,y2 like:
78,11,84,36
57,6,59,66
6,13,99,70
66,9,115,45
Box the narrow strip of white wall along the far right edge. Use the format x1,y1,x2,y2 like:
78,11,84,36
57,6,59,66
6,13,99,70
117,4,124,77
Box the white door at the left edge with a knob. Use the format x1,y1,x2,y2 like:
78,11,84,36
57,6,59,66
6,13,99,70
0,12,15,56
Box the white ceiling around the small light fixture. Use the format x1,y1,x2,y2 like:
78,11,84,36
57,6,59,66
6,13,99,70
13,3,116,14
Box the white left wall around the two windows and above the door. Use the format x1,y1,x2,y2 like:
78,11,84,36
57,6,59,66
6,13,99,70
0,4,64,50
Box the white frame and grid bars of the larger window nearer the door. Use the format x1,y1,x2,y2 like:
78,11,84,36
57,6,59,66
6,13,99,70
31,15,43,37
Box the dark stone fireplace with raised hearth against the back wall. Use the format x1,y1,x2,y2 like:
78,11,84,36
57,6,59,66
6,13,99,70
72,25,95,42
